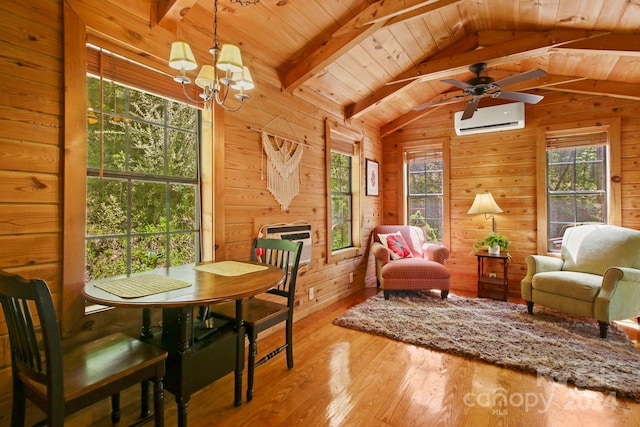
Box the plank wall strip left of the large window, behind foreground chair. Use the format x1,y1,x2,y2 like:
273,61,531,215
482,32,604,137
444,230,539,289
0,1,63,425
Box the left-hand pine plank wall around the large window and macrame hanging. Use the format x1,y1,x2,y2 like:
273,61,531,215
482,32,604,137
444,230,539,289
0,0,382,425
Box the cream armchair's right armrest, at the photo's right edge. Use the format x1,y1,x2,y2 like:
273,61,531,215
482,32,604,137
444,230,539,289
594,267,640,322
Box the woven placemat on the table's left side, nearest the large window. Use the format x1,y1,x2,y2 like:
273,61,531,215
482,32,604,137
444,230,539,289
94,274,191,298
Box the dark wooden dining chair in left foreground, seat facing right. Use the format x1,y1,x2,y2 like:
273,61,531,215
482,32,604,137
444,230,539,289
0,271,167,427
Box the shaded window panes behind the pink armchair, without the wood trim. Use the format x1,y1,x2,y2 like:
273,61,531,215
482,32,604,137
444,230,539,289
405,149,444,243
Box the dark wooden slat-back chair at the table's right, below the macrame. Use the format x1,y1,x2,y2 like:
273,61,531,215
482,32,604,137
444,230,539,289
210,239,302,401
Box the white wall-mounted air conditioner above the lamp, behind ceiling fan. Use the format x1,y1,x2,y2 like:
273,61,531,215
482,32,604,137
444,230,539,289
454,102,524,135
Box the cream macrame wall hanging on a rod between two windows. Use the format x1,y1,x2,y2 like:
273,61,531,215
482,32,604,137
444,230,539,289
252,116,306,210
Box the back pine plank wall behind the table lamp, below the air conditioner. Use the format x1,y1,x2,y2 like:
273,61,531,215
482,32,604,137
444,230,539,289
383,91,640,298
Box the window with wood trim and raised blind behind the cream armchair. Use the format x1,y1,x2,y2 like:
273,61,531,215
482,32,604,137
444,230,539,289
538,120,621,253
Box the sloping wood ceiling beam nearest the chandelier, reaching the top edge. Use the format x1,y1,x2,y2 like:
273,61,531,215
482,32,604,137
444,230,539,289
280,0,461,91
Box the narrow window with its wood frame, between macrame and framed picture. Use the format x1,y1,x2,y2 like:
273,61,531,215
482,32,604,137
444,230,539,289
325,120,364,262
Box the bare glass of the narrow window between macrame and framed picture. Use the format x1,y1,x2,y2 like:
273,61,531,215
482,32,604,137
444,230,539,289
331,152,353,250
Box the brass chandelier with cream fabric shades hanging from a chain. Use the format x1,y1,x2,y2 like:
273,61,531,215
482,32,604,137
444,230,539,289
169,0,260,112
